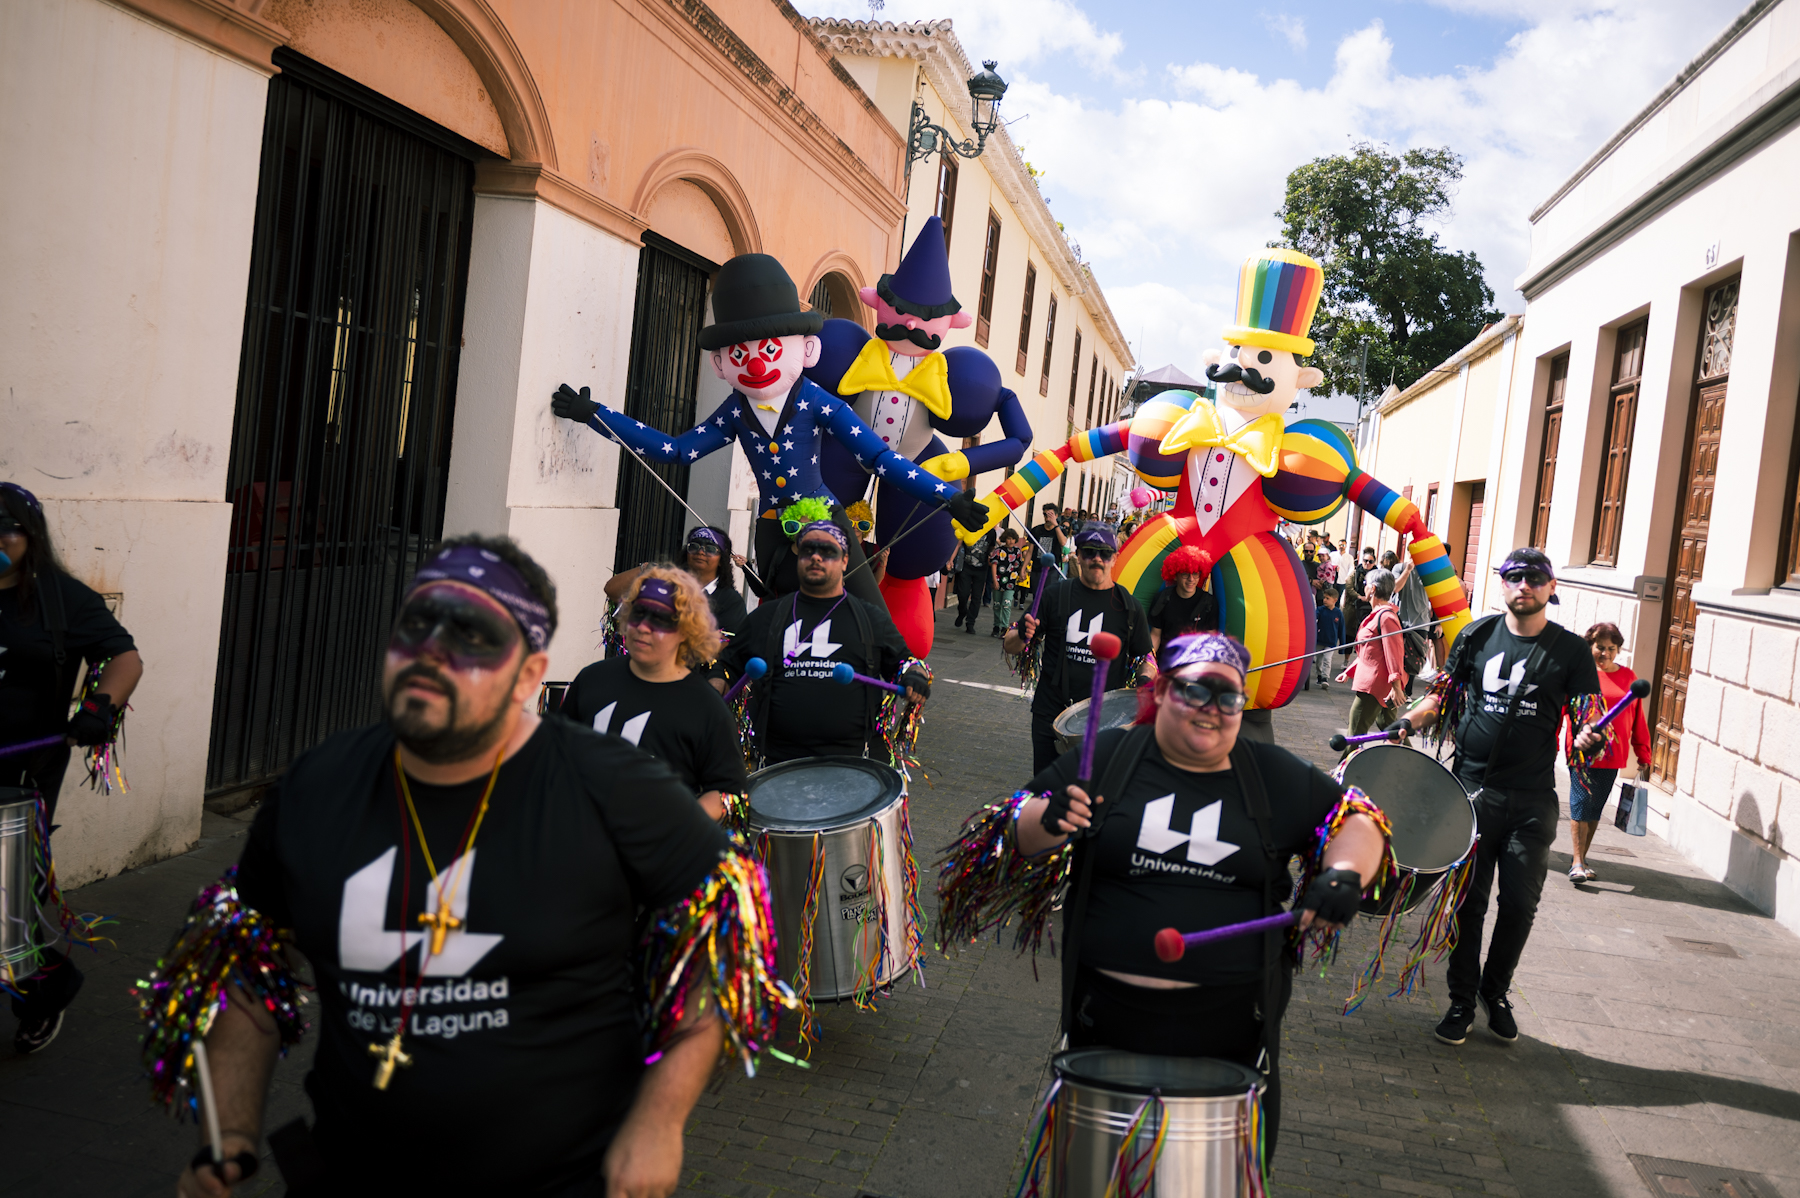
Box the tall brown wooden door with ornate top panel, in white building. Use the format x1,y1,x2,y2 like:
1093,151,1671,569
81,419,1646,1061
1651,279,1737,786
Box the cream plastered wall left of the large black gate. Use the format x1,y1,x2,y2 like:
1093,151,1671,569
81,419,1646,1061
0,0,268,885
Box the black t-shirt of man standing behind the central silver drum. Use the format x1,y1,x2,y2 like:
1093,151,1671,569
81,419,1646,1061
718,592,913,764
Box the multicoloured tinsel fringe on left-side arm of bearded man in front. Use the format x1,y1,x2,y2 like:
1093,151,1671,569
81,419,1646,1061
137,865,306,1121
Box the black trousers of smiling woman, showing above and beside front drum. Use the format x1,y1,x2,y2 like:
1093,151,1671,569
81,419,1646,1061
1067,966,1294,1160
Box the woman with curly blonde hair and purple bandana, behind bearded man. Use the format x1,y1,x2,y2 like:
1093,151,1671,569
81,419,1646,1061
562,563,749,820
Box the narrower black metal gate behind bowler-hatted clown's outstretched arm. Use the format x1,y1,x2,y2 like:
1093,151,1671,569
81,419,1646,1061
612,232,718,570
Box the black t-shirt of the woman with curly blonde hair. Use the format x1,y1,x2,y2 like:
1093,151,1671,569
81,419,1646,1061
560,657,749,795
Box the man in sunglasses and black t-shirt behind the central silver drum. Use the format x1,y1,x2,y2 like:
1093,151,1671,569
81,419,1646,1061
713,520,931,764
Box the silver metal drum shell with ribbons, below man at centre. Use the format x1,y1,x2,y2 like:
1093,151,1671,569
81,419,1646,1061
747,757,913,1002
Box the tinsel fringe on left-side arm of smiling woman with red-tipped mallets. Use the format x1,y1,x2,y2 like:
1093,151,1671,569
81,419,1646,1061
938,790,1075,955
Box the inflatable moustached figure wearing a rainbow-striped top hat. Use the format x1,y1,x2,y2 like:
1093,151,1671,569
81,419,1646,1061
958,250,1469,709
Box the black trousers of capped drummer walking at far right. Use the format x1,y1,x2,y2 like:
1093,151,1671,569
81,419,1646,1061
1445,786,1559,1007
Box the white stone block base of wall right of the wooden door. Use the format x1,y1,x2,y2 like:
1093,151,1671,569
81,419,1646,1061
1651,612,1800,930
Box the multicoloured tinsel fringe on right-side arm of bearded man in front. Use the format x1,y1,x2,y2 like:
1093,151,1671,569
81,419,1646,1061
643,853,799,1076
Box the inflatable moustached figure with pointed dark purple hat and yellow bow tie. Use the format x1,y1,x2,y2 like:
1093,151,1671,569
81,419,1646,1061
806,216,1031,657
